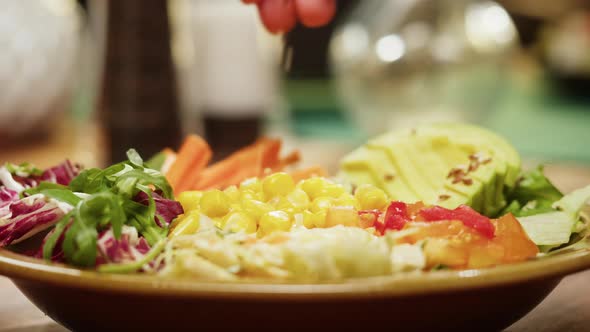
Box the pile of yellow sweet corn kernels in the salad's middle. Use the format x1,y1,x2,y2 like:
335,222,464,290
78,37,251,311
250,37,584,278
170,173,388,237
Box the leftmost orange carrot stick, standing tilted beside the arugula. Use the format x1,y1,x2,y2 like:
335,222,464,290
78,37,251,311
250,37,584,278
166,135,211,193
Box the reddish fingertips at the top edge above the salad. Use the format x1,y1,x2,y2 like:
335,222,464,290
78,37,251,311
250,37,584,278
242,0,336,33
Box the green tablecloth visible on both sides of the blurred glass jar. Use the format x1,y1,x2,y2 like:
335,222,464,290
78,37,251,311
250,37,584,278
285,79,590,164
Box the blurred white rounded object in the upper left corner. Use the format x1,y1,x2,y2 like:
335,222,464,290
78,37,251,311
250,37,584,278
0,0,80,139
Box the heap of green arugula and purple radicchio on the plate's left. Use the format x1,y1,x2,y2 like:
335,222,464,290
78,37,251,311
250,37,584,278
0,150,183,267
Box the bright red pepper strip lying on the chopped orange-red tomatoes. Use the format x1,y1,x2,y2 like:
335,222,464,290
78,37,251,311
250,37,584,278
419,205,496,239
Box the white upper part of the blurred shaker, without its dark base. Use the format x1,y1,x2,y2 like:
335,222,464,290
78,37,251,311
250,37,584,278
192,0,277,117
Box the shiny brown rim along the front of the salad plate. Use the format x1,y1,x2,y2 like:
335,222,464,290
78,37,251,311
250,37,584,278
0,249,590,301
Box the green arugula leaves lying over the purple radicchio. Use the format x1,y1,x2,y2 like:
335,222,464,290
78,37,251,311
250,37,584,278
39,149,178,267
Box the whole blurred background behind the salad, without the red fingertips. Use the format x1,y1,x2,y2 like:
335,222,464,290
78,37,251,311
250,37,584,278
0,0,590,175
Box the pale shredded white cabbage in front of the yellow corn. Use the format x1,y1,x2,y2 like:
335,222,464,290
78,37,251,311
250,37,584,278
160,226,425,281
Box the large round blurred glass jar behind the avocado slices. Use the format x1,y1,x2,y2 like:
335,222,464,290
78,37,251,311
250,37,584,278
330,0,517,135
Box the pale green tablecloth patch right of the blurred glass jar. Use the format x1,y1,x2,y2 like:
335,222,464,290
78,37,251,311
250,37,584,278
487,82,590,163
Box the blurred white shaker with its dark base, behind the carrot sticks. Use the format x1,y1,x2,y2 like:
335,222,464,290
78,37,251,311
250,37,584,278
192,0,277,159
